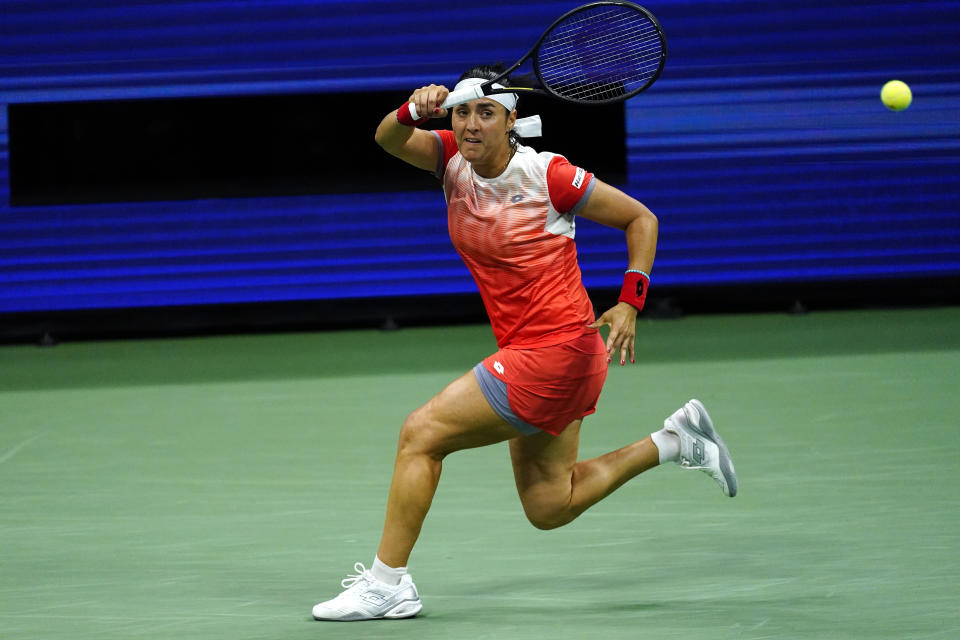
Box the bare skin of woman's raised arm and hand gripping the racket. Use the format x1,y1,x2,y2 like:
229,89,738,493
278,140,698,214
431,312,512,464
374,84,449,171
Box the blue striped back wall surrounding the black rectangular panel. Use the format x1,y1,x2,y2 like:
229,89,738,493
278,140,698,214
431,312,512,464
0,0,960,313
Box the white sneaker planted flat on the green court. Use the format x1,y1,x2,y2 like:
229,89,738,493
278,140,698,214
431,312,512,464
313,562,423,622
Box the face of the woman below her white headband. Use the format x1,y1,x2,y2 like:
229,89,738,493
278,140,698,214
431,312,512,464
451,98,517,165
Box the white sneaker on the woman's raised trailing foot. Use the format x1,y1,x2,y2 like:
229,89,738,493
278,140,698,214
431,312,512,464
663,399,738,498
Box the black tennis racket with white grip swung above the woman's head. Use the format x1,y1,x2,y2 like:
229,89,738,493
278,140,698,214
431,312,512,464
410,2,667,120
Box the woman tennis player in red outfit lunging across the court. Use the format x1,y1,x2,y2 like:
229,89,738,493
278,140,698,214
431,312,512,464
313,66,737,620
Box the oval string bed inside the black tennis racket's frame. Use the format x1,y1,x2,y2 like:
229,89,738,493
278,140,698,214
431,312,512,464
537,6,663,102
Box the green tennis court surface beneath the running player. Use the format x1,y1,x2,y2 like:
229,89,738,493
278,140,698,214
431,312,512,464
0,308,960,640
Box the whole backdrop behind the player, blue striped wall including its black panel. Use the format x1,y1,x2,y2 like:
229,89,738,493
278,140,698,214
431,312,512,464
0,0,960,335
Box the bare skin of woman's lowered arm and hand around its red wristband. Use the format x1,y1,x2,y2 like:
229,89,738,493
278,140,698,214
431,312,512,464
577,180,657,365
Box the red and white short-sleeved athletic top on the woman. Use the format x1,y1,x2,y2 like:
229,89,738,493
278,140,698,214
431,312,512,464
434,131,596,349
